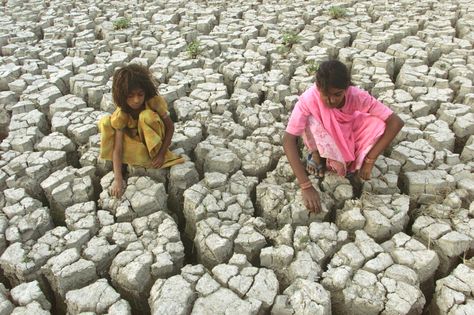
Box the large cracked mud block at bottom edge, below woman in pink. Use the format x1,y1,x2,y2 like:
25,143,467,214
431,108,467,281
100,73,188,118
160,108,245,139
321,231,434,314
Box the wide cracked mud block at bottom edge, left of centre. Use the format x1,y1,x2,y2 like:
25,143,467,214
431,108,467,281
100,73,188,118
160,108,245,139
148,254,279,315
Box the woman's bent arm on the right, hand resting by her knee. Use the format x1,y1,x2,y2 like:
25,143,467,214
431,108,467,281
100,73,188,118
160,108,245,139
359,113,405,180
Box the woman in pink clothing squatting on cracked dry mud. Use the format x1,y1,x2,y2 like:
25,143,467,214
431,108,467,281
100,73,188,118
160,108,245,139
283,60,403,212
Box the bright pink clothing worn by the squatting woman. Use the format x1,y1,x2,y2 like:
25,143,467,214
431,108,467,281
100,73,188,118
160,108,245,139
286,86,393,176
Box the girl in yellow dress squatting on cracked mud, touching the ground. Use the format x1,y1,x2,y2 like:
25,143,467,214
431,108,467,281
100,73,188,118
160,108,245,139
99,64,184,198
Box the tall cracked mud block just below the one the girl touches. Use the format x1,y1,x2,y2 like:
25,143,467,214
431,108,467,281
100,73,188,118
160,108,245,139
99,211,184,312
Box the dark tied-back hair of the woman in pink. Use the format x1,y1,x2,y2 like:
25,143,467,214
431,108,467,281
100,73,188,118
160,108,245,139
316,60,352,92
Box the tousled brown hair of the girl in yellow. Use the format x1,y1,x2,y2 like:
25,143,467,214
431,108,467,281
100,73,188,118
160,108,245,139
112,63,158,112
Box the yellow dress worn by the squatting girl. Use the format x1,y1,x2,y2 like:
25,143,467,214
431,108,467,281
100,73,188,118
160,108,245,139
99,95,184,168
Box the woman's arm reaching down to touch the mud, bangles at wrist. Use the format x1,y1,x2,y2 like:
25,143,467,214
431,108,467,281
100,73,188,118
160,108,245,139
283,132,321,213
